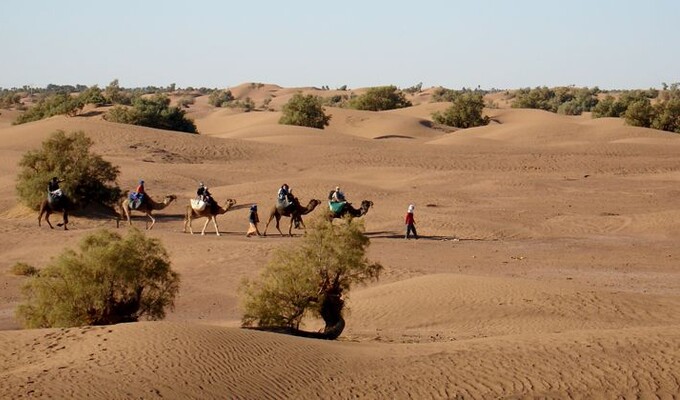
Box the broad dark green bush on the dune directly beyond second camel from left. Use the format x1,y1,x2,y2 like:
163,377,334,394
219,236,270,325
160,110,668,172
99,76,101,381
105,94,198,133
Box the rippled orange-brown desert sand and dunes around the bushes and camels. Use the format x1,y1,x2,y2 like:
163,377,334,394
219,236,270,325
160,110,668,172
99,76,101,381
0,84,680,399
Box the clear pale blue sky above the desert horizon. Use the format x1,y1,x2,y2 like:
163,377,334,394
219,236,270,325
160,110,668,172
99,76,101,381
0,0,680,89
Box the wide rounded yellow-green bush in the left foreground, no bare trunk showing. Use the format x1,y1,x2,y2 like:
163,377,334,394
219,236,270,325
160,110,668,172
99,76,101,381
17,229,179,328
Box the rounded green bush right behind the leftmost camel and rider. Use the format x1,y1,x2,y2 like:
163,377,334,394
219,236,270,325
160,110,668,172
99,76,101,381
16,131,121,209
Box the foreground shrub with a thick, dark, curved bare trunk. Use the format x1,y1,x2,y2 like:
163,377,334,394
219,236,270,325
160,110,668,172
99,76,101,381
242,218,382,339
